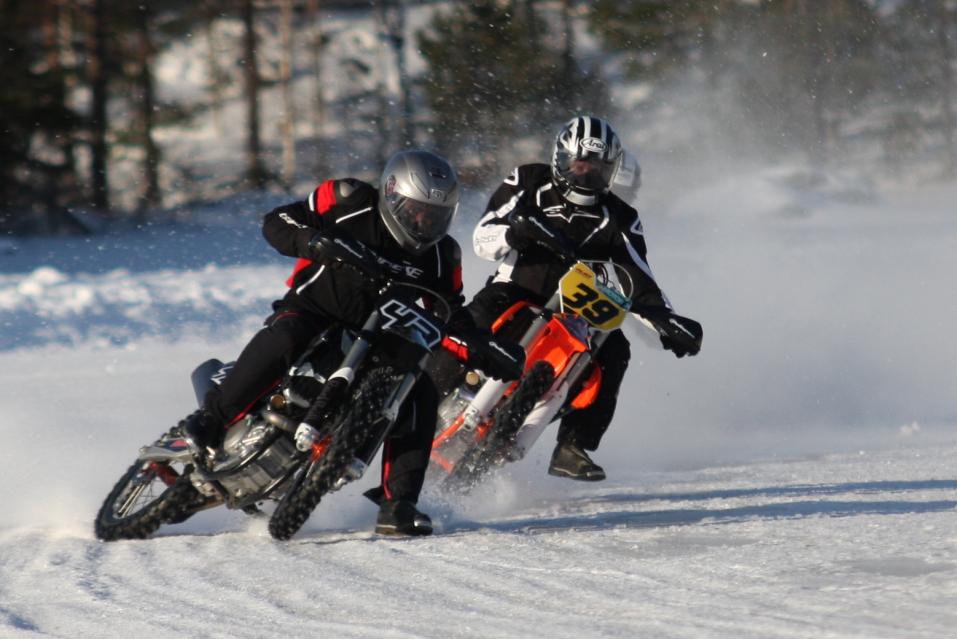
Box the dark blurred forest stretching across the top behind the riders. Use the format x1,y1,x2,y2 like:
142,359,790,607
0,0,957,234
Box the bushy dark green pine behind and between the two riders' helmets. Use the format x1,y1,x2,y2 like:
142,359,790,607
419,0,607,179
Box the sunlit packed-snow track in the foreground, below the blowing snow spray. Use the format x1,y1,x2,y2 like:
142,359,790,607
0,445,957,639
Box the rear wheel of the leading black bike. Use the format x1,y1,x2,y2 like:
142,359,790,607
94,461,202,541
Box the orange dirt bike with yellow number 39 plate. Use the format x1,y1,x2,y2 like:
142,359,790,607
429,258,700,492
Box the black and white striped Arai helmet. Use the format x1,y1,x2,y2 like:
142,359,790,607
552,115,622,206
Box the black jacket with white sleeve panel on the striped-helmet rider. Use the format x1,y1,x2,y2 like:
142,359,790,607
472,164,671,309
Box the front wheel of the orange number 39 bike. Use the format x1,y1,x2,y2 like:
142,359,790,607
442,362,555,493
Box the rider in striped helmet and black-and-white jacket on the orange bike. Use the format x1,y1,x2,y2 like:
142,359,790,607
467,116,701,481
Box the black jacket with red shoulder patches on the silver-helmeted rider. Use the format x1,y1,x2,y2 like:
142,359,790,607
263,178,464,327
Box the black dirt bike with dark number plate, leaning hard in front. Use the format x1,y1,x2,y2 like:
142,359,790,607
94,238,450,541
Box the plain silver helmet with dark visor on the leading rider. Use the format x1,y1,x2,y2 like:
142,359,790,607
379,151,459,255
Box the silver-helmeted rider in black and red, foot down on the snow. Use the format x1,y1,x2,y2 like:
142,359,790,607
183,151,521,535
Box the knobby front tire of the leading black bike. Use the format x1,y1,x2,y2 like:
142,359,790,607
269,367,400,541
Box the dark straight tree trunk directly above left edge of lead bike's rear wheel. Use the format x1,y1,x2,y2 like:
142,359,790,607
87,0,110,211
